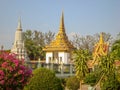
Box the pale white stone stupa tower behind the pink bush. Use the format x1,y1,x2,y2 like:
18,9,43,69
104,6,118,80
11,19,29,61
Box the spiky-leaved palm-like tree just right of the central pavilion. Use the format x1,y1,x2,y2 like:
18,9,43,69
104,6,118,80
73,50,90,90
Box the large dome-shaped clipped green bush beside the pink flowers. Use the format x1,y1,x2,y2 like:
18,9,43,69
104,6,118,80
25,68,63,90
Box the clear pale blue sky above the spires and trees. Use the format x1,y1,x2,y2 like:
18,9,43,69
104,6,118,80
0,0,120,49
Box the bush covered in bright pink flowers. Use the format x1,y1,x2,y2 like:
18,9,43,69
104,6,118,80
0,52,32,90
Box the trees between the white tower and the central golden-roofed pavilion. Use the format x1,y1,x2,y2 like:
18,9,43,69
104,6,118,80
24,30,55,60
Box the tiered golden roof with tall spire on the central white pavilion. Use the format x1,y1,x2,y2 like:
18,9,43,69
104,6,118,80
43,13,74,51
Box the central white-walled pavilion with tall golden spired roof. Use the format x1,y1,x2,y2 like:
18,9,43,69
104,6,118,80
43,12,74,64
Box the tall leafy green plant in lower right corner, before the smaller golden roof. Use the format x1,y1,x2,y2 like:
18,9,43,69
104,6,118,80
88,53,120,90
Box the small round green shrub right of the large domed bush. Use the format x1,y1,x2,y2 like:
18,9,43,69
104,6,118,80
66,76,80,90
